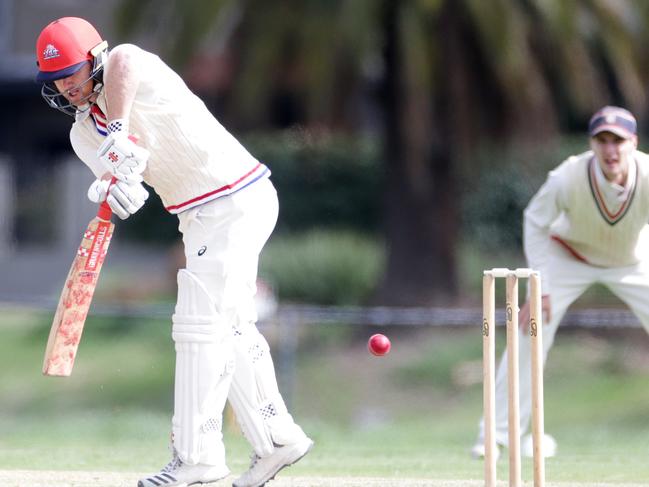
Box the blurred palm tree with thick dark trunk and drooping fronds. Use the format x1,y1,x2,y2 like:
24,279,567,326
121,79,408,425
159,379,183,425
115,0,649,304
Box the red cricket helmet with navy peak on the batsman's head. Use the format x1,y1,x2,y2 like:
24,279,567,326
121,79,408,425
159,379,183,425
36,17,108,83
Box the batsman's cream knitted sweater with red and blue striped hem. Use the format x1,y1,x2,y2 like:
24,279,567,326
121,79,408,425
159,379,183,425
70,44,270,213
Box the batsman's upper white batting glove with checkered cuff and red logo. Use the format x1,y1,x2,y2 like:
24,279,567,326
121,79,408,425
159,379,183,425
97,123,150,183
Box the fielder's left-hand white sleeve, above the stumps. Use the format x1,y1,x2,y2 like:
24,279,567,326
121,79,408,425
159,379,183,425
523,164,564,294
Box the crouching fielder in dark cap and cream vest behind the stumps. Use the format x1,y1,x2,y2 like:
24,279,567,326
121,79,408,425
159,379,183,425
472,106,649,457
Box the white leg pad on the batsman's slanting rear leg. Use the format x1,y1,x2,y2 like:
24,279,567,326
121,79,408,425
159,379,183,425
228,322,306,457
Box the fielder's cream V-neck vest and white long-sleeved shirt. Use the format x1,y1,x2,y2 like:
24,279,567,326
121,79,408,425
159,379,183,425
524,151,649,289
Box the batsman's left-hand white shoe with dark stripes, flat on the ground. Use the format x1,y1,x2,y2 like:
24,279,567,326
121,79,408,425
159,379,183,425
137,452,230,487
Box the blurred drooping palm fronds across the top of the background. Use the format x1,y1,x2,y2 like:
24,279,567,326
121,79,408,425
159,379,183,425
115,0,649,130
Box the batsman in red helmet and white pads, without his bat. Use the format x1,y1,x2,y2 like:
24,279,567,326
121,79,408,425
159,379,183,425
36,17,313,487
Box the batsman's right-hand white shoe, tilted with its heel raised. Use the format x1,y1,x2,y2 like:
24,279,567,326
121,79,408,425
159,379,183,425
232,437,313,487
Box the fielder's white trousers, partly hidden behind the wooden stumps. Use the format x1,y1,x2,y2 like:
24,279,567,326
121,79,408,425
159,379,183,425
479,241,649,445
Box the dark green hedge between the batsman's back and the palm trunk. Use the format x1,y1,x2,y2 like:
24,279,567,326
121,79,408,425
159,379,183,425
243,130,384,232
